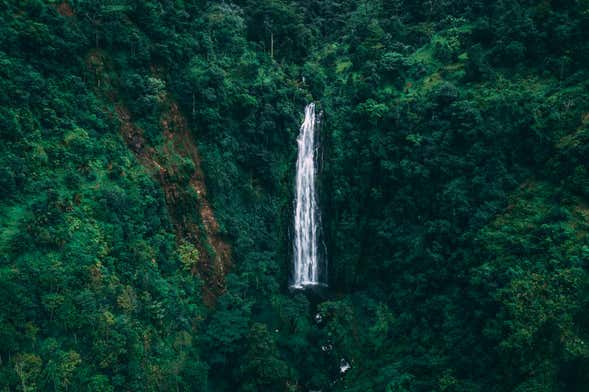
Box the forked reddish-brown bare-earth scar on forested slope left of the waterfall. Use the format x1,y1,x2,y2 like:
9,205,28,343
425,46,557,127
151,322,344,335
86,50,231,306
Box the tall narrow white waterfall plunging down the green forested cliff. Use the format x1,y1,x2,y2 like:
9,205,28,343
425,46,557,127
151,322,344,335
293,103,327,288
